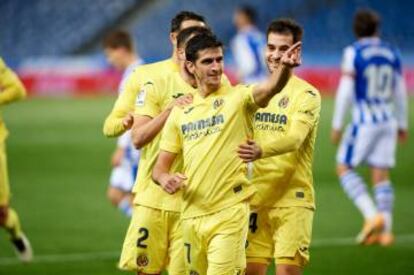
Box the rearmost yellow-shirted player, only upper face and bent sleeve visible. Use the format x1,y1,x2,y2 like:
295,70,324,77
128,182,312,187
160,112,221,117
103,11,206,137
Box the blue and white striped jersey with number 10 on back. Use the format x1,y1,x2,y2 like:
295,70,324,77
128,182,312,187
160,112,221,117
333,38,407,129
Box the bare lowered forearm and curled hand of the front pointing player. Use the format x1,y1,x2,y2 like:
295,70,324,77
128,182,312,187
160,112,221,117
152,150,187,194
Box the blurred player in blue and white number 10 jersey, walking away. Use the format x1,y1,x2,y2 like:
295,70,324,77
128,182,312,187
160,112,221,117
331,10,408,246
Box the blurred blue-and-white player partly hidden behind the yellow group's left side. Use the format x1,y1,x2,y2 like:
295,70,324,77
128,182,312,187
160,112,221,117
103,31,143,217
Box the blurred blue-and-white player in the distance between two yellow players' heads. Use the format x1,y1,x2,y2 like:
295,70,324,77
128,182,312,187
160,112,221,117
231,6,267,83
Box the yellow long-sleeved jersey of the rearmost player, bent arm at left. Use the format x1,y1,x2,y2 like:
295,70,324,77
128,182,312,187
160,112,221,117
103,59,179,137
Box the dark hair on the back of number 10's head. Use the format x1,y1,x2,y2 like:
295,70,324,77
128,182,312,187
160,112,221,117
353,9,381,38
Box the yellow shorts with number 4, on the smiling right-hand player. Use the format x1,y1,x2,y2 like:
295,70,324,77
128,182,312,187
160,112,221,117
246,207,314,267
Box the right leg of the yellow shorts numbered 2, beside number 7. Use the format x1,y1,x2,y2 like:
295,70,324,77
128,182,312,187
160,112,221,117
167,212,185,275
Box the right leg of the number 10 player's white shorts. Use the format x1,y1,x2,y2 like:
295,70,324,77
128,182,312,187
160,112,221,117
367,122,398,170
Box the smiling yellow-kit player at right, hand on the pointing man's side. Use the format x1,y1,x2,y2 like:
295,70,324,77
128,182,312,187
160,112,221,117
238,19,321,275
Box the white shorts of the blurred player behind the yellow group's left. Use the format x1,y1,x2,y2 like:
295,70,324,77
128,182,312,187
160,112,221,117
109,159,137,193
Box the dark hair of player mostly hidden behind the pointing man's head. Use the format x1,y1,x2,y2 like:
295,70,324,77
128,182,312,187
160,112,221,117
185,33,223,62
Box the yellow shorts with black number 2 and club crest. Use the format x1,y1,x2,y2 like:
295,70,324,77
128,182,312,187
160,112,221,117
119,205,185,275
